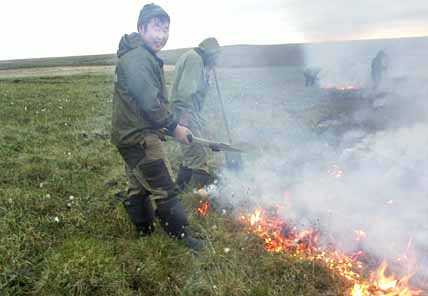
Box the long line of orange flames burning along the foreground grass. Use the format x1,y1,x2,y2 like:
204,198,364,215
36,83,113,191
240,209,422,296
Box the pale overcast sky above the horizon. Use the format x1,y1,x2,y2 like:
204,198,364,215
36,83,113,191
0,0,428,60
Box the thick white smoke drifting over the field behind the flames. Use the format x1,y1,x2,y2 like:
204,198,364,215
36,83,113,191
205,38,428,286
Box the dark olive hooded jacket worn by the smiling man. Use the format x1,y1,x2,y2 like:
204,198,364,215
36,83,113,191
111,33,177,147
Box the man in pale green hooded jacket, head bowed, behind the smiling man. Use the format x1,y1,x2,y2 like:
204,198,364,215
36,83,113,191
170,38,220,190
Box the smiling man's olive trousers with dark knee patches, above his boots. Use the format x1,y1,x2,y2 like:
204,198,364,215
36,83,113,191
119,133,177,200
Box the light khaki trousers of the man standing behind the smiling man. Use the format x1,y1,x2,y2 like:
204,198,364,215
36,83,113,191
180,119,208,173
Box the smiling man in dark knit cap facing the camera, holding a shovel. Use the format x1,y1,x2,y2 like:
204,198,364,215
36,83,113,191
111,4,201,249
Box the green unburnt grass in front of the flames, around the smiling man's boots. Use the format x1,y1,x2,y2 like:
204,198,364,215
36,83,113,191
0,75,352,296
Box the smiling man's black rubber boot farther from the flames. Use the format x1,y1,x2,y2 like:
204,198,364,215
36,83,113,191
122,195,155,236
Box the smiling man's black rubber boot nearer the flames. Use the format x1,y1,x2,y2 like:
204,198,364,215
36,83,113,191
156,197,204,251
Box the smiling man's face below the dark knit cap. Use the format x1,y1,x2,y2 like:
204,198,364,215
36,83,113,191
140,17,169,53
